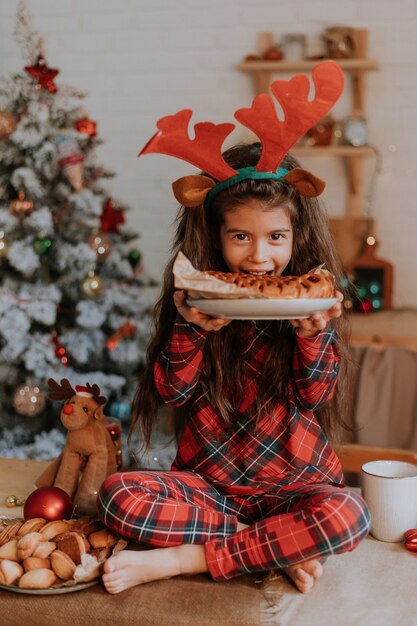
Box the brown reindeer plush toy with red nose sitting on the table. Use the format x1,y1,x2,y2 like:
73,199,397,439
36,378,116,515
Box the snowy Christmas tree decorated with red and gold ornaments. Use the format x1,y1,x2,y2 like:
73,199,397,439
0,3,150,458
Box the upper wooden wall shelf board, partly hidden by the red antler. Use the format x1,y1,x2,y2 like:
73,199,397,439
237,59,379,73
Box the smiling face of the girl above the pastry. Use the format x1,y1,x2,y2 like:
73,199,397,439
220,198,293,276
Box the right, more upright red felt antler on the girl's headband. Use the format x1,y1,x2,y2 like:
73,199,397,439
235,61,344,172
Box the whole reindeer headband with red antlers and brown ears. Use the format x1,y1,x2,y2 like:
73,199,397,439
138,61,344,207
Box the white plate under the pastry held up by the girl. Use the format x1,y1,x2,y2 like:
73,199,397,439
187,298,337,320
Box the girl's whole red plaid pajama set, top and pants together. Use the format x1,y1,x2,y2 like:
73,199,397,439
98,317,369,580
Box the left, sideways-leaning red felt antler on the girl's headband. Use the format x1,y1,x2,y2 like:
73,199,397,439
138,109,236,180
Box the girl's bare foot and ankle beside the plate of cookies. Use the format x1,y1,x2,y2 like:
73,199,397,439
103,545,207,593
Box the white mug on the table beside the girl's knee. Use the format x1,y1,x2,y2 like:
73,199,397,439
361,461,417,542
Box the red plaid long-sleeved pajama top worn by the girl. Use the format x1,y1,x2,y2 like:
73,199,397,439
154,315,343,495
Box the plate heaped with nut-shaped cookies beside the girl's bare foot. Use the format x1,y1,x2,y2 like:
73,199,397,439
0,517,128,595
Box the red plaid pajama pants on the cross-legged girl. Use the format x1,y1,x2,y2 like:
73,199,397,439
97,471,369,580
